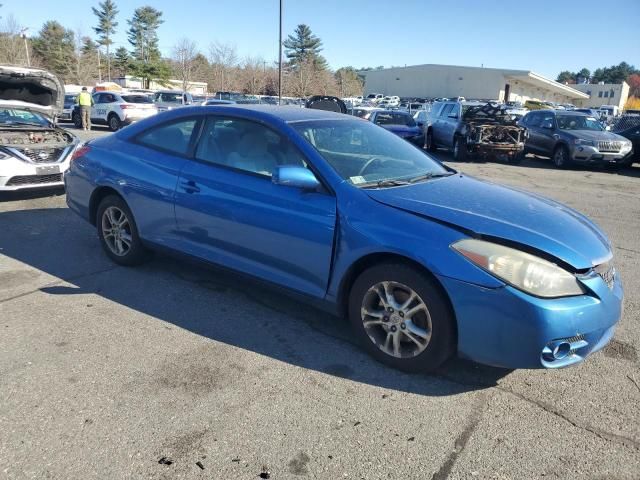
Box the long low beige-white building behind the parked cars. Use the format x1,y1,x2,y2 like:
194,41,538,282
359,64,588,104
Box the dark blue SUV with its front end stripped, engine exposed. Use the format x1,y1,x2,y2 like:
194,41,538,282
424,102,527,164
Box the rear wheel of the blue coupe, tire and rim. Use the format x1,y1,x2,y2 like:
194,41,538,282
96,195,148,266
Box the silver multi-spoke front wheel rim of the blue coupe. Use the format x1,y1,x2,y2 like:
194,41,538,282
361,282,432,358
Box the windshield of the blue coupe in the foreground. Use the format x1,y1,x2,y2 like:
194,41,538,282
292,120,449,187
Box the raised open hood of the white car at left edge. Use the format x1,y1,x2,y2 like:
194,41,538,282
0,66,64,118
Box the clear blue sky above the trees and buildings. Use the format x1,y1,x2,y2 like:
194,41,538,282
0,0,640,78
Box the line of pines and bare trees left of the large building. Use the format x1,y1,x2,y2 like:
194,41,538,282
0,0,363,97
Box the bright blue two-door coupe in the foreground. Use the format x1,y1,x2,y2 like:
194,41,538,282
65,106,623,371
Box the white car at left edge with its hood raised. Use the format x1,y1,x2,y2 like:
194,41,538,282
0,66,78,191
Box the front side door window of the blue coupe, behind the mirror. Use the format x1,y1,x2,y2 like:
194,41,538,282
196,117,306,176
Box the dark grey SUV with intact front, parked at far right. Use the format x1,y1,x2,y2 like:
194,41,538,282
520,110,632,168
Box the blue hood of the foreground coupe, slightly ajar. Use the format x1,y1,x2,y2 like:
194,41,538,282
365,174,611,270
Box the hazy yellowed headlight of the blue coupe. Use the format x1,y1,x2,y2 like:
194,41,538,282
452,239,585,298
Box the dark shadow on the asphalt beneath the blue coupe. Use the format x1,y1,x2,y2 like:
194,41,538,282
0,208,511,396
